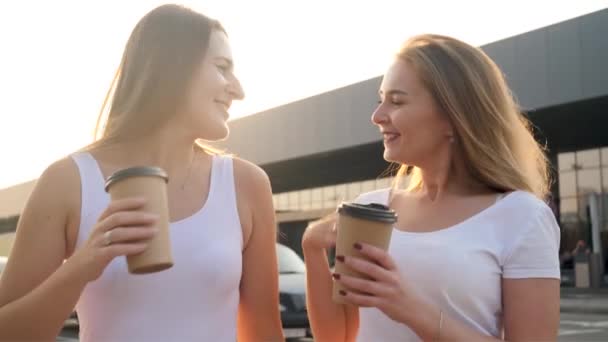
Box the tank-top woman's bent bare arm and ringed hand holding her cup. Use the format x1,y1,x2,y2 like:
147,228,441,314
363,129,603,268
0,160,159,341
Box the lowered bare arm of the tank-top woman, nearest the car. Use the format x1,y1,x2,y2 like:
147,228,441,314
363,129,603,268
235,159,284,342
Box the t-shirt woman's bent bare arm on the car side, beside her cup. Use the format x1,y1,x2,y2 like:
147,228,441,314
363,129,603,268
302,215,359,342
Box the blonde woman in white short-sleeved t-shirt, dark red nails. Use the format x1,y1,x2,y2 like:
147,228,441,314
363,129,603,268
302,35,560,342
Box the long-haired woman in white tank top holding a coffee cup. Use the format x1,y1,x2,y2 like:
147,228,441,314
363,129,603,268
0,5,283,342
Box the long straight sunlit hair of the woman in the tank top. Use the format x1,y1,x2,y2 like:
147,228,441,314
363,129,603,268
88,5,225,148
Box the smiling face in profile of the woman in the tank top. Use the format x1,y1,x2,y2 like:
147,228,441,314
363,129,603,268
178,30,244,141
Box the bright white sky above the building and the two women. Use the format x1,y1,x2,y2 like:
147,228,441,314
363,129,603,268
0,0,608,189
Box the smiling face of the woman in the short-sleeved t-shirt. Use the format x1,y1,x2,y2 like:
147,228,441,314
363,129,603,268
372,59,453,166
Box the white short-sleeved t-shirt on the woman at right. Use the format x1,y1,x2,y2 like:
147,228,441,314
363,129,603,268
356,189,560,342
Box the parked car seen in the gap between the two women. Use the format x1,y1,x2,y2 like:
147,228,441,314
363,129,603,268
277,243,311,338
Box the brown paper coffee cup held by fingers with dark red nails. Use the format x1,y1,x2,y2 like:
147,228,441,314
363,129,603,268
332,203,397,304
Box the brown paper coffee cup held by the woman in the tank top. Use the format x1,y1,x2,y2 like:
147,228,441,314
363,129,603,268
105,166,173,274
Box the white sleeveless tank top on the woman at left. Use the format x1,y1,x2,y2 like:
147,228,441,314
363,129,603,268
72,153,243,342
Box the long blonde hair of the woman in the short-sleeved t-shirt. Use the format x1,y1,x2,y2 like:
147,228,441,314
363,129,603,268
395,34,550,199
